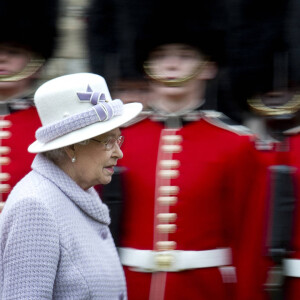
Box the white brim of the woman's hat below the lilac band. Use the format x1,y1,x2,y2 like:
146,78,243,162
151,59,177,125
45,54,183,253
28,103,143,153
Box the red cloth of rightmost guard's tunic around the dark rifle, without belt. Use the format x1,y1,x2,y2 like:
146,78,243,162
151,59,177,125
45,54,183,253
250,135,300,300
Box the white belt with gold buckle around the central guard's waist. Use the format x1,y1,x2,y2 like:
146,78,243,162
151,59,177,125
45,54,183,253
118,248,231,272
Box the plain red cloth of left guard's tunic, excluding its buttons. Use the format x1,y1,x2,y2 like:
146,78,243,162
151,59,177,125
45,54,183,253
0,107,41,201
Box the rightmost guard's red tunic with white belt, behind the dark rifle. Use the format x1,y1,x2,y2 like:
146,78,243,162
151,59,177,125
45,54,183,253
252,133,300,300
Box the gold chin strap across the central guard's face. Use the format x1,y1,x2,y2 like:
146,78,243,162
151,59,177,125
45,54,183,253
143,62,206,87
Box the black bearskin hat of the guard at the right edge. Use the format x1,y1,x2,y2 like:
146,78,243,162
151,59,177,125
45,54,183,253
229,0,300,110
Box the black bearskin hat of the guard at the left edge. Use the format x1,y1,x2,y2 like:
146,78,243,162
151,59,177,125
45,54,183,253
0,0,58,59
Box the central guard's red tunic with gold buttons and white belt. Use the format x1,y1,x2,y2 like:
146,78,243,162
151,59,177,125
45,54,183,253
118,112,257,300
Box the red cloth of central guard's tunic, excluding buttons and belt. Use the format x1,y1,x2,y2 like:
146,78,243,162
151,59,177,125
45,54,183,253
119,119,264,300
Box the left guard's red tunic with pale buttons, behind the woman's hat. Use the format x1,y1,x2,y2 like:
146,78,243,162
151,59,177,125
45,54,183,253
0,106,41,201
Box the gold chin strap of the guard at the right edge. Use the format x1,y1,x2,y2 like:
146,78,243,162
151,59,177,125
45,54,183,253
248,94,300,116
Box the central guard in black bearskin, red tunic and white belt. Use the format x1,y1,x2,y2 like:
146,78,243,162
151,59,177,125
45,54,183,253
93,1,258,300
